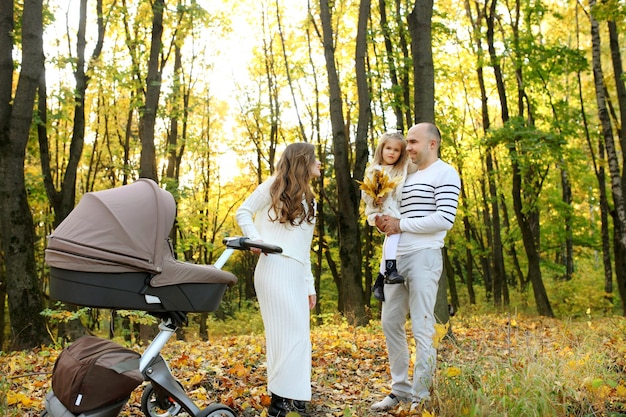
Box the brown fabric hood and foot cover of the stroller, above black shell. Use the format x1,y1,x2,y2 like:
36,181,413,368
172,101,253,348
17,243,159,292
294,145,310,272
46,179,236,287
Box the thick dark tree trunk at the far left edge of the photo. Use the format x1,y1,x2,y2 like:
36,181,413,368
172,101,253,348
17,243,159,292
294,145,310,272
0,0,47,350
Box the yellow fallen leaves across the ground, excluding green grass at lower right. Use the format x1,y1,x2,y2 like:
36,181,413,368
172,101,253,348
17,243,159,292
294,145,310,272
0,316,626,417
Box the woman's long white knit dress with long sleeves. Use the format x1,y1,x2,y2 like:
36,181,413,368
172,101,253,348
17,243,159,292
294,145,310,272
236,177,315,401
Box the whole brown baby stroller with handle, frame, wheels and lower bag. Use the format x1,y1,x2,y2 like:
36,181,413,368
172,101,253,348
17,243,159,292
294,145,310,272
41,179,282,417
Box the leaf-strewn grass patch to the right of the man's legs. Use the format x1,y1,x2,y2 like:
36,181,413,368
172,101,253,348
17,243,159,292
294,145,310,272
428,316,626,417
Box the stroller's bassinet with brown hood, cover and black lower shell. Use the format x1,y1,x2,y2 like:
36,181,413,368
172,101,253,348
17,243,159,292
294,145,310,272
45,179,237,313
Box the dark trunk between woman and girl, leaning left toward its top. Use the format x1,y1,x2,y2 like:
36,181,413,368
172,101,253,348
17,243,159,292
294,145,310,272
320,0,368,324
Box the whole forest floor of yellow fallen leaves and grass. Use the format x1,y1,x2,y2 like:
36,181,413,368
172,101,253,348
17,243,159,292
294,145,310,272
0,314,626,417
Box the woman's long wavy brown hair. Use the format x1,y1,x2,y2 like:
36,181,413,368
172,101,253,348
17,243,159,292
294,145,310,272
270,142,316,226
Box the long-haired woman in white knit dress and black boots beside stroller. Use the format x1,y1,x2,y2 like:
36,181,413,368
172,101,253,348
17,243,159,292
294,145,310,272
237,143,321,417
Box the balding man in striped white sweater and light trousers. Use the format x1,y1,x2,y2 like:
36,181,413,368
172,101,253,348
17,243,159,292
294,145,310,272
371,123,461,411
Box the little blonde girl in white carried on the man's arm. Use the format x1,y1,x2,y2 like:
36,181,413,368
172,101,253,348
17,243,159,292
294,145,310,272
361,132,417,301
